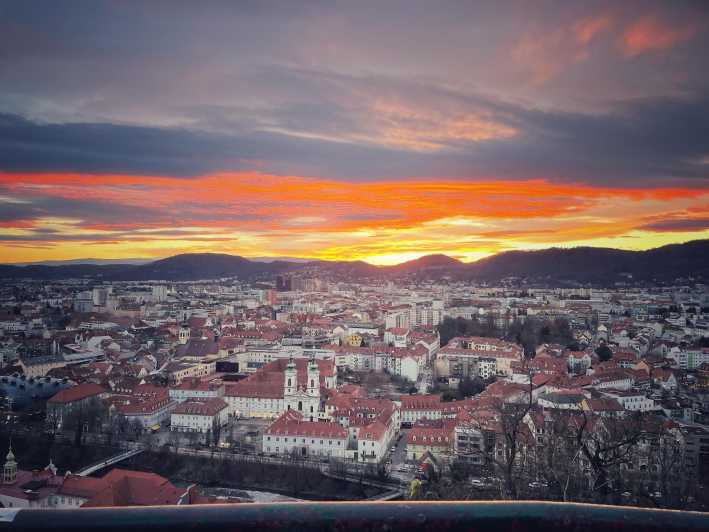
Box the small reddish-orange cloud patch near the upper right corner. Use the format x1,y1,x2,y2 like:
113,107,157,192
621,15,698,57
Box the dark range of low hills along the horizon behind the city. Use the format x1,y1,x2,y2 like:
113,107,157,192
0,240,709,284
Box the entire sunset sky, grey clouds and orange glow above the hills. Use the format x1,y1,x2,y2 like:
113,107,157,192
0,0,709,264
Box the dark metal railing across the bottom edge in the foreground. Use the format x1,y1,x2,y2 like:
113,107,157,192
0,501,709,532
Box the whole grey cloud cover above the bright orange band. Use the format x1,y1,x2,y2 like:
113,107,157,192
0,0,709,186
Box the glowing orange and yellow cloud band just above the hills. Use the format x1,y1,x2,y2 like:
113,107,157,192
0,172,709,263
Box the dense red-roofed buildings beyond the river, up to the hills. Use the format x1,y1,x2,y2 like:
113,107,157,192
0,272,709,506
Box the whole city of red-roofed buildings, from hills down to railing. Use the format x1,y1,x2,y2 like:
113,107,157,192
0,251,709,510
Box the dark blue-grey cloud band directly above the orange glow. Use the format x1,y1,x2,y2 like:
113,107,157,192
0,90,709,186
